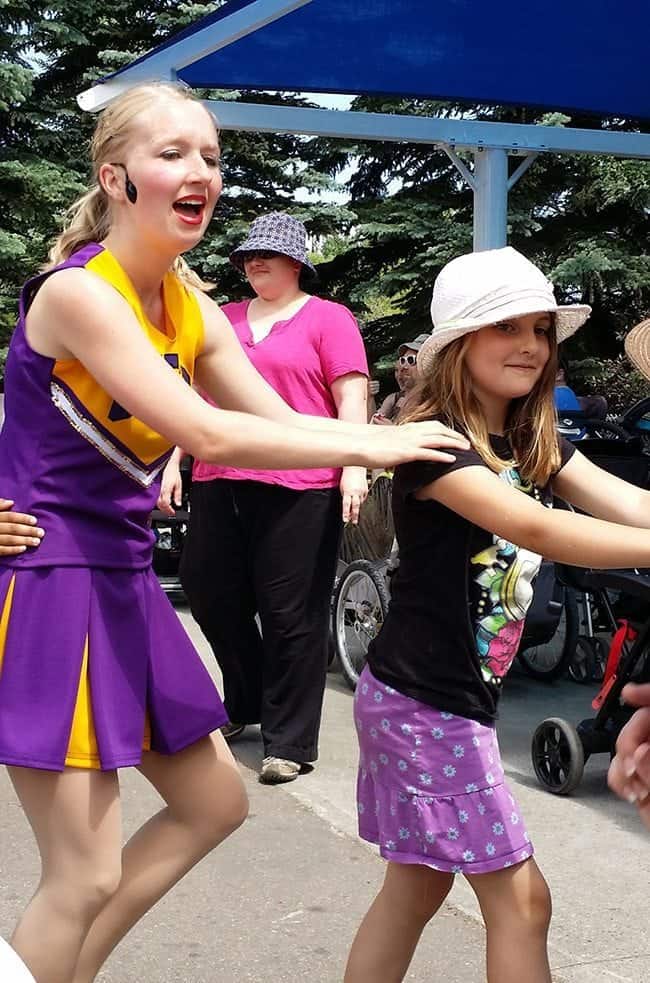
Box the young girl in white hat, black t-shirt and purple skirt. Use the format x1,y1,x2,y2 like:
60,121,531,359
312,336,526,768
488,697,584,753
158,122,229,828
345,248,650,983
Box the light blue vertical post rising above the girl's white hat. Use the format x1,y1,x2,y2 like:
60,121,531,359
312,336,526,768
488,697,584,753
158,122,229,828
474,147,508,252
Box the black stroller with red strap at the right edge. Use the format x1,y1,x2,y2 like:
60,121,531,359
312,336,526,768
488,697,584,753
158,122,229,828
531,422,650,795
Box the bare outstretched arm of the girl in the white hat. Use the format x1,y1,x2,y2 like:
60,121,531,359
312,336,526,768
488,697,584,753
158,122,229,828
416,466,650,568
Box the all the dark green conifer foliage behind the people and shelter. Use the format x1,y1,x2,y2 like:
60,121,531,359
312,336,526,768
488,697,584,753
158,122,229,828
0,6,650,399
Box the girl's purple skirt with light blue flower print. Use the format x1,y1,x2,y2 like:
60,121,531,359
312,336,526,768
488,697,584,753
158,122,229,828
354,666,533,874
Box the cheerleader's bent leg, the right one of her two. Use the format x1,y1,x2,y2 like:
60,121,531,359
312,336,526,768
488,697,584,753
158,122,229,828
72,733,248,983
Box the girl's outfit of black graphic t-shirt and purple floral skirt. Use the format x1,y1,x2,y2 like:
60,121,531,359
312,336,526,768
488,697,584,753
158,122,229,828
355,437,574,874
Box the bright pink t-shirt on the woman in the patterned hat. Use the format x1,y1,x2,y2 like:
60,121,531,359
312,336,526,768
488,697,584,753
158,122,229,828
192,297,368,491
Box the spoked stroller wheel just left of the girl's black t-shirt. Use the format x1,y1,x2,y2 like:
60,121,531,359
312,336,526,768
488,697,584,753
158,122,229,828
332,560,389,689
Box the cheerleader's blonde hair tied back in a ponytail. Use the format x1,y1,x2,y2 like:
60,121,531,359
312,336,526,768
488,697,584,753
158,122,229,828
44,82,218,290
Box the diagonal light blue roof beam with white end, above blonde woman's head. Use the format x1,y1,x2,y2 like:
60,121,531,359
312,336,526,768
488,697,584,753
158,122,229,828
77,0,312,113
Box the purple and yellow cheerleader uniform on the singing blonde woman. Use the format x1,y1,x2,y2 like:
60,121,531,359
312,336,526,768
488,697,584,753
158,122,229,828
0,244,227,771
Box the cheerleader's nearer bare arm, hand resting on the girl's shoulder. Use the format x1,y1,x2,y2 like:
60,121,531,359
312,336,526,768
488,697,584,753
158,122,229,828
21,269,466,469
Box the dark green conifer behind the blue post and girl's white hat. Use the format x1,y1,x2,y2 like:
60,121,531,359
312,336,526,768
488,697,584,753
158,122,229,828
308,97,650,368
